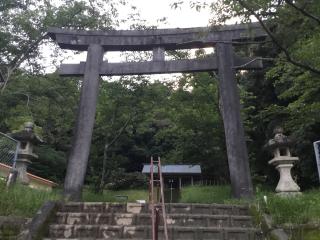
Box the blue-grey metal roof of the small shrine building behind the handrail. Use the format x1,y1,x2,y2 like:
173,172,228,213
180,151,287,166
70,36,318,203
142,164,201,174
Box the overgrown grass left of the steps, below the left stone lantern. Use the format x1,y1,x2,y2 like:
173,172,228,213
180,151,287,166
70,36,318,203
0,182,59,217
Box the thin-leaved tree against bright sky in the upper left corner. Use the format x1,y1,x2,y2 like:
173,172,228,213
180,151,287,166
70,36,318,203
0,0,125,92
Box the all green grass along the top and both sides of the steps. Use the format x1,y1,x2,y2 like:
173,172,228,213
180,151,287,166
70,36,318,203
0,184,320,224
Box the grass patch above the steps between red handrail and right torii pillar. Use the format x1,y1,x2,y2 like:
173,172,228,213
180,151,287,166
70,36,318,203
180,185,231,203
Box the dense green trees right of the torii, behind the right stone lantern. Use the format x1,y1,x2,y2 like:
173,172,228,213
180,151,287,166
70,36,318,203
212,0,320,188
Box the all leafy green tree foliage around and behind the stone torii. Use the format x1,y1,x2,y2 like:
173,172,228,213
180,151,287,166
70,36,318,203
0,0,320,190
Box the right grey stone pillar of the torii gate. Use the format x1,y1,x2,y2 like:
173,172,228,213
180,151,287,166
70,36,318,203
216,43,253,198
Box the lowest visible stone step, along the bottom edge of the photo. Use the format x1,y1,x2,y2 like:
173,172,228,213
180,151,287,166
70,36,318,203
49,224,259,240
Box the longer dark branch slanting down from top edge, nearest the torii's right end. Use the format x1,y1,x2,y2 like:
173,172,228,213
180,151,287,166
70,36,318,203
237,0,320,74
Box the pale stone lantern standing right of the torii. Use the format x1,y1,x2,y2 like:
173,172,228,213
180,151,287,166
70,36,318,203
266,127,300,196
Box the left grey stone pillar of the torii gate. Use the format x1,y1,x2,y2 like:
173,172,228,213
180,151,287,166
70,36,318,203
63,44,104,201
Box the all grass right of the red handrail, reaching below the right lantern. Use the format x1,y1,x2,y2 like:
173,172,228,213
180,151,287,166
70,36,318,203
180,186,320,225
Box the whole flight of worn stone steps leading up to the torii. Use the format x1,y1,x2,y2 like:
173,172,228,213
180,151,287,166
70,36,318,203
44,202,263,240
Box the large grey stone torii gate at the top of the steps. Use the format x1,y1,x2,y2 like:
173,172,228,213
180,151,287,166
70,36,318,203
48,24,266,200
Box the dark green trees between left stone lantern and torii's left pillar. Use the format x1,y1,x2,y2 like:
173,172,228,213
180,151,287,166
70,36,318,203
0,73,79,183
